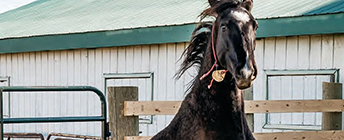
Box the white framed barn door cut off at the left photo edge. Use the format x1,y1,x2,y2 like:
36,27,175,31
0,77,10,118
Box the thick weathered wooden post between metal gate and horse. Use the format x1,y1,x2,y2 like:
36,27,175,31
108,87,139,140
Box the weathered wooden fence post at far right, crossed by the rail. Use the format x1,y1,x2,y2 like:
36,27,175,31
322,82,342,130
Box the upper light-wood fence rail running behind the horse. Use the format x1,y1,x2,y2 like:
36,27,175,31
124,99,344,116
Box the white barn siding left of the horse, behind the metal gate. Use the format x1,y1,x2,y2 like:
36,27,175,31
0,43,191,135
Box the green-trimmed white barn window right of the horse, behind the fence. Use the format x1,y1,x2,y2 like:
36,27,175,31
263,69,339,130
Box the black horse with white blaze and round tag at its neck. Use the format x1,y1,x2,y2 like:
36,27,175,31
152,0,258,140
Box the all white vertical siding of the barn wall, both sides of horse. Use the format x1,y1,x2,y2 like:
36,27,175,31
0,34,344,135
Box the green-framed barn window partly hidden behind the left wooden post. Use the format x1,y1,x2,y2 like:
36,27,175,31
104,72,154,124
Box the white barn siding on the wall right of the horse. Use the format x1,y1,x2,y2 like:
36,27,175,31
253,34,344,132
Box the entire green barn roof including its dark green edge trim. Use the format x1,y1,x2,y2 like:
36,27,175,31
0,0,344,53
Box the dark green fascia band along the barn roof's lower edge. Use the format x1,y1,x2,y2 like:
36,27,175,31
0,13,344,54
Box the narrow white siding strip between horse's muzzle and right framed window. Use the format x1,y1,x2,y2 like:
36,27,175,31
253,39,266,133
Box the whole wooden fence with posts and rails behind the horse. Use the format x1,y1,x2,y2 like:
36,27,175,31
108,83,344,140
